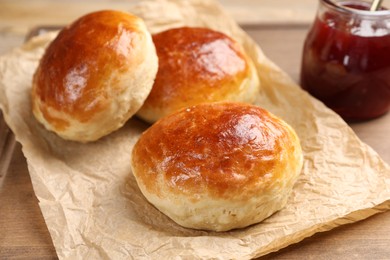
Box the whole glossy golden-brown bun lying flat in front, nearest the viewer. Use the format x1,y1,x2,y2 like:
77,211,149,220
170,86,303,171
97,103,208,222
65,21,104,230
131,102,302,231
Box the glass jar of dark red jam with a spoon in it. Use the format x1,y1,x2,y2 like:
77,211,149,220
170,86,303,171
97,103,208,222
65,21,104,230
301,0,390,120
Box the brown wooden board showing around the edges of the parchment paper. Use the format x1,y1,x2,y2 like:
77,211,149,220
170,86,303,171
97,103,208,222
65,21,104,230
0,24,390,259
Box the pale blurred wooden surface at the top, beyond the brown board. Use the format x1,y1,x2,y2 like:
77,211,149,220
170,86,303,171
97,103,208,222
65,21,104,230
0,0,318,55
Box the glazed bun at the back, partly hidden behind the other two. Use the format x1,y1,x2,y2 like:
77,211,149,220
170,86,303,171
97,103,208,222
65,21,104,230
137,27,259,123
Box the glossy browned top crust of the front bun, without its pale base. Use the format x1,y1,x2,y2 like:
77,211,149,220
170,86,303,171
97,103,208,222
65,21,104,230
132,103,300,200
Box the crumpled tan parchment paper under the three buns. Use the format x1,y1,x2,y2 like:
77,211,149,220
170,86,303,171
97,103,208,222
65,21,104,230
0,0,390,259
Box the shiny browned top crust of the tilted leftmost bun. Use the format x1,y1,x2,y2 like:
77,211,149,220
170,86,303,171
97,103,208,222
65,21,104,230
33,11,143,128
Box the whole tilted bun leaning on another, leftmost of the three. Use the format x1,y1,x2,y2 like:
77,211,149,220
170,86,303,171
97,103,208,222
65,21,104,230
32,11,158,142
